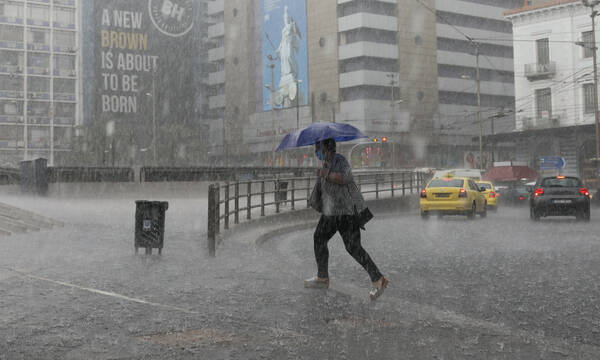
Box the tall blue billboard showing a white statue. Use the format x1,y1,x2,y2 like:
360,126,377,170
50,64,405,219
261,0,309,111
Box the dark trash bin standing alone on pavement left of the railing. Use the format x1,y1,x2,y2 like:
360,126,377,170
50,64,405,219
134,200,169,254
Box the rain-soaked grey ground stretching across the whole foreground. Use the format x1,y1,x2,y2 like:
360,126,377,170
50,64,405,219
0,190,600,359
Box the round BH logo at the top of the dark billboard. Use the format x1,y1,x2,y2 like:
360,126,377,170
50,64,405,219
148,0,194,37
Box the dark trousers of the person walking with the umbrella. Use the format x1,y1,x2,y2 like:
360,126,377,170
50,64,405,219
314,215,381,282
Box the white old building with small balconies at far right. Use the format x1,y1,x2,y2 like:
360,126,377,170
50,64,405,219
503,0,600,175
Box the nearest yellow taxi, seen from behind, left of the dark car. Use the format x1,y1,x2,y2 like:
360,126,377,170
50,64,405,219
420,177,487,219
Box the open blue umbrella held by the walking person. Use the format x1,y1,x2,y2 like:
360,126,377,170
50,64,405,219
277,123,368,151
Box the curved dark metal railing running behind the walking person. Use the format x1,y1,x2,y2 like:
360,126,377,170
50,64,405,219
207,171,429,256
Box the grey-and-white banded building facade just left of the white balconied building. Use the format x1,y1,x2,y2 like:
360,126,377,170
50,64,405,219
436,0,522,136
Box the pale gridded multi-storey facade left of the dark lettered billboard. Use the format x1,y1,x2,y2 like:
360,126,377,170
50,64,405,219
0,0,81,166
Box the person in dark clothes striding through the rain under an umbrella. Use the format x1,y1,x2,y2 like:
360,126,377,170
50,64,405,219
304,139,389,300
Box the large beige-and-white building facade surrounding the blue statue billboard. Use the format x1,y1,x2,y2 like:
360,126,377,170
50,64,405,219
207,0,437,166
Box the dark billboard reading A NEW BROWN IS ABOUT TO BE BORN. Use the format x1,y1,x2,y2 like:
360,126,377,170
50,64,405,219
93,0,199,134
